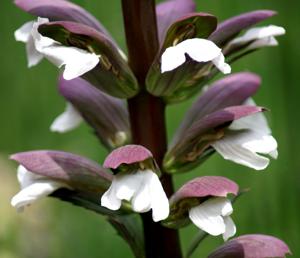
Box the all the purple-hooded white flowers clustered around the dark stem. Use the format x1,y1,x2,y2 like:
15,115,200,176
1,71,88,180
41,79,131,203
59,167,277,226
11,0,289,258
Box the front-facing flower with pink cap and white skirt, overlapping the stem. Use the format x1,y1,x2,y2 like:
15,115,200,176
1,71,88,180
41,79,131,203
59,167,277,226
101,145,169,222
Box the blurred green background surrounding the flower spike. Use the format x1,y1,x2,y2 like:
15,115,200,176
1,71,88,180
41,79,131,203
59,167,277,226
0,0,300,258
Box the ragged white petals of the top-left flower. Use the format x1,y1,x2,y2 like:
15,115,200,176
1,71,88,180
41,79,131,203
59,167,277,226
15,18,99,80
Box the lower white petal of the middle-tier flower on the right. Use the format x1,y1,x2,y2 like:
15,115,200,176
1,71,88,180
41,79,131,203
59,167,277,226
212,130,275,170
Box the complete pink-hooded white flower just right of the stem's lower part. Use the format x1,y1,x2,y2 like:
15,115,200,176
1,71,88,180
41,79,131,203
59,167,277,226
164,176,239,241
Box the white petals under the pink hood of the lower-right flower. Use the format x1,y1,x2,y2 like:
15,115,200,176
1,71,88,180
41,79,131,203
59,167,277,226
189,197,236,241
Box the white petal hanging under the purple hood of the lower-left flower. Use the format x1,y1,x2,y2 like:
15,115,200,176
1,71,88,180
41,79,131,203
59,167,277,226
11,179,65,211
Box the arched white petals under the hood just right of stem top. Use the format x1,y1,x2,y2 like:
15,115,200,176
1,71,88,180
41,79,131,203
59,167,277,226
161,38,231,74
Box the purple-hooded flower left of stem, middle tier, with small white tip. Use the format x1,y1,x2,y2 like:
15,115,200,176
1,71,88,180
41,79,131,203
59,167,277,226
51,76,130,149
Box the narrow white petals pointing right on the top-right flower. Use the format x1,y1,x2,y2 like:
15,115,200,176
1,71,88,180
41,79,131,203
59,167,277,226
229,25,285,50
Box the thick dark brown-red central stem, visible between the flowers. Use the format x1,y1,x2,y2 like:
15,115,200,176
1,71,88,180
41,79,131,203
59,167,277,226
122,0,182,258
